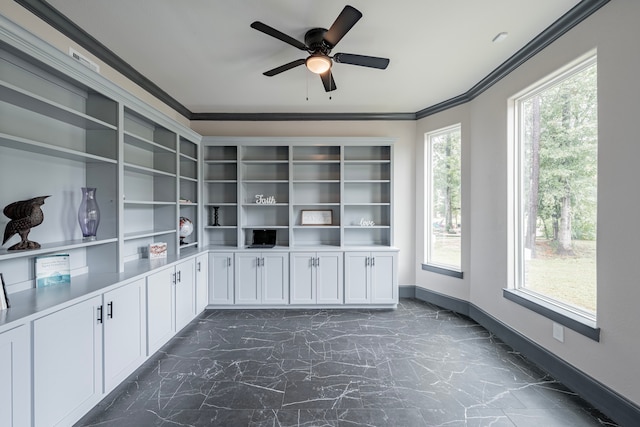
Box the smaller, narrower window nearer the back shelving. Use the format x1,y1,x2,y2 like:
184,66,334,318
423,124,462,277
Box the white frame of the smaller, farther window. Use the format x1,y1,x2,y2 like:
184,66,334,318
422,123,464,279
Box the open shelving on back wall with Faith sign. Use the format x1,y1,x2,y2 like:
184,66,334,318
203,137,393,248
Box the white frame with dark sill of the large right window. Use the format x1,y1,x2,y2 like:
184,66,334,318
503,49,600,341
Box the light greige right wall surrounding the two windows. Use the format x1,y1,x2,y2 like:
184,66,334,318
416,0,640,404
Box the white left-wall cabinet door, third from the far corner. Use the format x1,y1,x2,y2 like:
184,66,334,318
147,268,174,356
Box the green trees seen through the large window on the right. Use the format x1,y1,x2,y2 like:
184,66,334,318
521,64,598,244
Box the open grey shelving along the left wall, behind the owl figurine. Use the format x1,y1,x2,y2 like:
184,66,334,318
0,21,201,293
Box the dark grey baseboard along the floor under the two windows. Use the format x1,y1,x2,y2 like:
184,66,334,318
399,285,640,426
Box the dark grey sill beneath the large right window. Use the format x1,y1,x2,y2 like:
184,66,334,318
502,289,600,342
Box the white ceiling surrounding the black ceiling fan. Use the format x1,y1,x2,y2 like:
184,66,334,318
48,0,579,113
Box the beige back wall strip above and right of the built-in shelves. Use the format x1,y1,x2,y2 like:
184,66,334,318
191,121,416,285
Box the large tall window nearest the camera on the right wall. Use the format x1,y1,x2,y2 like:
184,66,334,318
513,56,598,321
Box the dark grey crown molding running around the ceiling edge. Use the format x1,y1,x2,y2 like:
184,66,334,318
14,0,610,121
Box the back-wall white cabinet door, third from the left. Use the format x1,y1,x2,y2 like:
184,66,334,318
260,252,289,304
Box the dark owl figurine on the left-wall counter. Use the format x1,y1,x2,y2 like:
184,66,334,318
2,196,50,251
